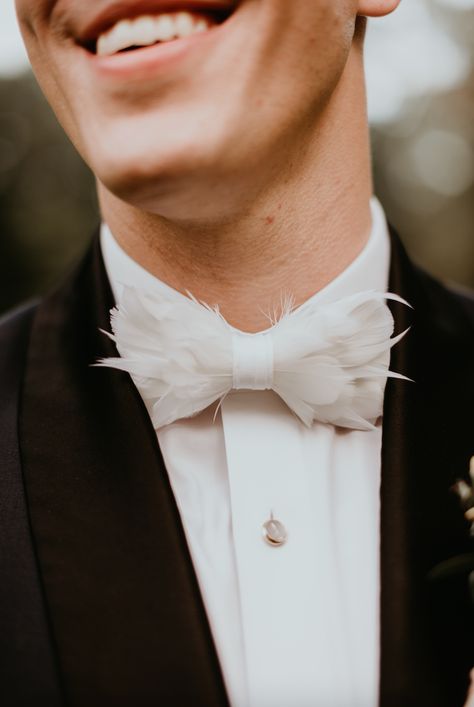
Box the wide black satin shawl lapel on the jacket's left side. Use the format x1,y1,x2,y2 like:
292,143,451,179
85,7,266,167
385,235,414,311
21,243,227,707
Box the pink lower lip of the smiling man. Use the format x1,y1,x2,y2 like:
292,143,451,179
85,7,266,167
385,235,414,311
88,18,231,79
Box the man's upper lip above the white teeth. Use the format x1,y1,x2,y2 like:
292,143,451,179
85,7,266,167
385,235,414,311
76,0,239,44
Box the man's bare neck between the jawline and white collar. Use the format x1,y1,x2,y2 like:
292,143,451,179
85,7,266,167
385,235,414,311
99,49,372,332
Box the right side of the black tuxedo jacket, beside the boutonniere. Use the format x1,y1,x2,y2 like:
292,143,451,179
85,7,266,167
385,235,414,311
380,235,474,707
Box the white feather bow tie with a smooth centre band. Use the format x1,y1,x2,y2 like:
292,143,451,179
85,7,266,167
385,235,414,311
98,288,406,430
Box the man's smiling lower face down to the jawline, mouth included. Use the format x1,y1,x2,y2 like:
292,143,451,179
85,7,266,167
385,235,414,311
16,0,357,215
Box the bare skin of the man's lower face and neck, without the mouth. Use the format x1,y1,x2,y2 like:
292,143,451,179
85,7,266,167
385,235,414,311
16,0,399,331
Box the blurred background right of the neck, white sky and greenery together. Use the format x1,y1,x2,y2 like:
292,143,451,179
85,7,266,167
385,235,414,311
366,0,474,296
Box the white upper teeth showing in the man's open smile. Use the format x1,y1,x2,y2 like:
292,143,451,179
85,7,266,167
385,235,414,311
80,5,239,57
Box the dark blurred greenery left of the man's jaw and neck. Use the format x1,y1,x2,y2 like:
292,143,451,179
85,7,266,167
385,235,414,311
0,73,99,311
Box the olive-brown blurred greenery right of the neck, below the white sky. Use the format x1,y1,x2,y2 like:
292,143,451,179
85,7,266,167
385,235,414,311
372,74,474,289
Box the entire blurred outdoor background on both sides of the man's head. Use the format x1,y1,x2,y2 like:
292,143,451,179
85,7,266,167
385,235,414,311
0,0,474,311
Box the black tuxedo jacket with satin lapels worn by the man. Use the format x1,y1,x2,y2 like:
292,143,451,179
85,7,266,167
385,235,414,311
0,234,474,707
